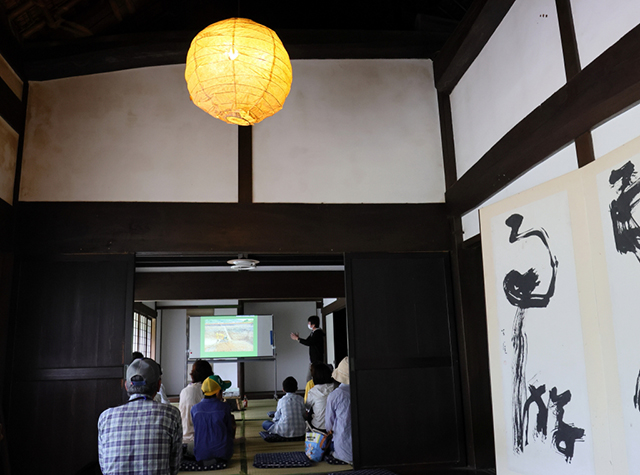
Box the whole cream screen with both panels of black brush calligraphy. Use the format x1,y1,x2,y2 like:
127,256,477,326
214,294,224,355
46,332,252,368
480,137,640,475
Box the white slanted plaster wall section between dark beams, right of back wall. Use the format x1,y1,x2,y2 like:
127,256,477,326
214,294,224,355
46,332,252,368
451,0,566,177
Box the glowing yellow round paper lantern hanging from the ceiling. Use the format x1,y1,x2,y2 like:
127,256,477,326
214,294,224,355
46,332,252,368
184,18,292,125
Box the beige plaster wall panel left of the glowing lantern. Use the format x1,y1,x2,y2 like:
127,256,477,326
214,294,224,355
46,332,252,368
20,65,238,202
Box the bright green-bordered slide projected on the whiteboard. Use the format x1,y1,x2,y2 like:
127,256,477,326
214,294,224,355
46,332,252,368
200,317,258,358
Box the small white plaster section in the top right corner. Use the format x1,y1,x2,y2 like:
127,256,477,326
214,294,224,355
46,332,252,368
571,0,640,68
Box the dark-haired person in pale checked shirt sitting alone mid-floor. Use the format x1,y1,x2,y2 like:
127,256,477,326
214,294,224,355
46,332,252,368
262,376,306,437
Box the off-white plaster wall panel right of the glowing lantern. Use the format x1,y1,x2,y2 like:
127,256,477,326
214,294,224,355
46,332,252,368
253,60,444,203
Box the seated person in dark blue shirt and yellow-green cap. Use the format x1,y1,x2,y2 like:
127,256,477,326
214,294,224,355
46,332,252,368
187,375,236,465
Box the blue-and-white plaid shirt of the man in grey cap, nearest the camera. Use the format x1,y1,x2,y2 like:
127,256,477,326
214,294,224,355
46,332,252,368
98,394,182,475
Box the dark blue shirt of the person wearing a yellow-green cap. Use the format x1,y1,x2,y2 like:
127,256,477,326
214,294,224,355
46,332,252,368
191,397,235,461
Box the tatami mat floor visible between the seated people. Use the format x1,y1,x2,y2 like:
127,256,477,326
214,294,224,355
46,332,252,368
180,399,353,475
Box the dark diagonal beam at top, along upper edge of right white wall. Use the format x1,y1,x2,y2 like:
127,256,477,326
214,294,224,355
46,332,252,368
433,0,515,93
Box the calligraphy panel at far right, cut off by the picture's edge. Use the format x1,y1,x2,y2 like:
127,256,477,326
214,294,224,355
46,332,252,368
580,138,640,474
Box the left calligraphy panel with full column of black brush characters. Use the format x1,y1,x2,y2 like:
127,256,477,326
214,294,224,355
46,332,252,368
480,162,616,475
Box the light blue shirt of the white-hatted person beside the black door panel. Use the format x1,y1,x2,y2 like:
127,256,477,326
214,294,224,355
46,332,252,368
324,383,353,463
